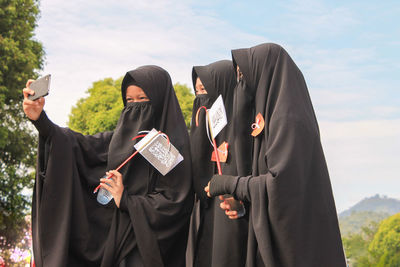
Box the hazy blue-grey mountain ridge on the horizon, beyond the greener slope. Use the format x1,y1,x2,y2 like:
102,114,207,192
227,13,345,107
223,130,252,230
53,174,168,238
339,194,400,218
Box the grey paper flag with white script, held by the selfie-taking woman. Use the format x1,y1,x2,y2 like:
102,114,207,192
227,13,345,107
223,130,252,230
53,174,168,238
134,129,183,176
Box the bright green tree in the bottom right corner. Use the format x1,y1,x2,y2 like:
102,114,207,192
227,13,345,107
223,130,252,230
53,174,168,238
368,213,400,267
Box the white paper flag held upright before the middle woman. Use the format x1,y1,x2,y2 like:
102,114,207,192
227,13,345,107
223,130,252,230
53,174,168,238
208,95,228,139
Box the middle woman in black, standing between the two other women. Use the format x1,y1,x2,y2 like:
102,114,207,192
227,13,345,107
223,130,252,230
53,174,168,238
187,60,248,267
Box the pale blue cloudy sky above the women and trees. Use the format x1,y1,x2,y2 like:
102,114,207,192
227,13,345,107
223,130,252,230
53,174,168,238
35,0,400,212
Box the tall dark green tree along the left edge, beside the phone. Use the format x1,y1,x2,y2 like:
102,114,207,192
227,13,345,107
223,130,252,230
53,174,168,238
0,0,44,250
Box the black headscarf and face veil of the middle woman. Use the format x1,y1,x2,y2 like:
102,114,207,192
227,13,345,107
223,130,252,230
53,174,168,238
190,60,236,205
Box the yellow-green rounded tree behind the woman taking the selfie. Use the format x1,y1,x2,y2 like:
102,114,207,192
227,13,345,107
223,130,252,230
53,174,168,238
68,78,194,134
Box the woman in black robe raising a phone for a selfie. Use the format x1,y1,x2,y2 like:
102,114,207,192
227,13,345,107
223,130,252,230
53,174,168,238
24,66,193,267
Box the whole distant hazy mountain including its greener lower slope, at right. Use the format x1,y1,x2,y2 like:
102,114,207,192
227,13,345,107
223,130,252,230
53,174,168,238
339,195,400,236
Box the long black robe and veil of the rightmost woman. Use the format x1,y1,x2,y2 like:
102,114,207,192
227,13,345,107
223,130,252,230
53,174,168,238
211,44,346,267
